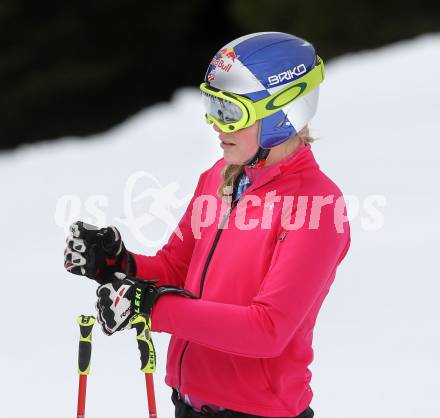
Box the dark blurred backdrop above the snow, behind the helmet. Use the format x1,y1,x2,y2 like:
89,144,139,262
0,0,440,149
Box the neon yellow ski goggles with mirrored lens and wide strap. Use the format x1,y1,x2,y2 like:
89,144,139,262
200,57,324,132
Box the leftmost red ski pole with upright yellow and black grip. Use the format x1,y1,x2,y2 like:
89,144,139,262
76,315,96,418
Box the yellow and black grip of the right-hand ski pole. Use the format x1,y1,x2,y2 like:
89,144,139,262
130,314,156,373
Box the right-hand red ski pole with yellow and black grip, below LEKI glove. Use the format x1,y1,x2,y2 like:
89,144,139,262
130,314,157,418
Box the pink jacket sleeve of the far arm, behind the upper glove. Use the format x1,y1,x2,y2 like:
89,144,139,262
132,172,206,288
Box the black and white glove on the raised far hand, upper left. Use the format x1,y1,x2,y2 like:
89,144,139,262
64,221,136,284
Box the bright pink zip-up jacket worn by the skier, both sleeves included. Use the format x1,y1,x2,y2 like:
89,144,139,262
135,145,350,417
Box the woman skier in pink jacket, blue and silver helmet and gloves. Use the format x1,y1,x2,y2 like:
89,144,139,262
65,32,350,418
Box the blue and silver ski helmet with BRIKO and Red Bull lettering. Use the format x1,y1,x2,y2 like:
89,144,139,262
201,32,324,152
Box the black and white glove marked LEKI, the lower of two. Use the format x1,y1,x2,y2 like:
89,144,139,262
96,273,197,335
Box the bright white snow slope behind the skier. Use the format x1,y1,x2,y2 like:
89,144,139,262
0,34,440,418
